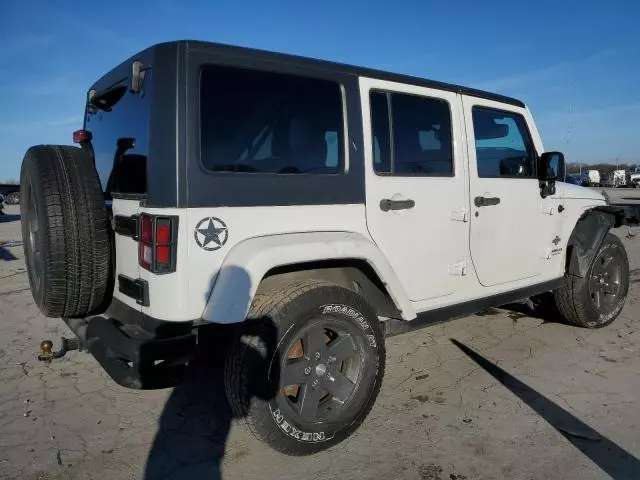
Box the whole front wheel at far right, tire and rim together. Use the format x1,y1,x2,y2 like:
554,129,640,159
554,233,629,328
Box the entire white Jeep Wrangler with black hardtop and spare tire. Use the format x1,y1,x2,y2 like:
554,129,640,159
20,41,629,455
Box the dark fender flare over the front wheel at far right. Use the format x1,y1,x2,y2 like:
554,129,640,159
567,205,625,278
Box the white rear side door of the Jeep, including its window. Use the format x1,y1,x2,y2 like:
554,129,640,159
360,78,469,302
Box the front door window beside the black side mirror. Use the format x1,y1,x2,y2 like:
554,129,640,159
473,107,536,178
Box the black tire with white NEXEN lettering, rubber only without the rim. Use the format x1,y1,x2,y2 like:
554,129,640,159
225,280,385,455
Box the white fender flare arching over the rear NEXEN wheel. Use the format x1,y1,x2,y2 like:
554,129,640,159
202,232,416,324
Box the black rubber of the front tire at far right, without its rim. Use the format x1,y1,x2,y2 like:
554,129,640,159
553,233,629,328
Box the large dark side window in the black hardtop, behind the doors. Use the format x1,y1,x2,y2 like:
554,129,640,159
200,67,344,174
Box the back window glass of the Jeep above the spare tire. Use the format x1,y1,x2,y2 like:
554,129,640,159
85,70,151,194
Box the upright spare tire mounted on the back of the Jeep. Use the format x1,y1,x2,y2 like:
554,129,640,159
20,145,111,318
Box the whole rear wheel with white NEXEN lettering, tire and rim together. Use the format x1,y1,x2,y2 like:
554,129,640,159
225,280,385,455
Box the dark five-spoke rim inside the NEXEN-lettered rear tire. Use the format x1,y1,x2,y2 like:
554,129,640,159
278,319,364,424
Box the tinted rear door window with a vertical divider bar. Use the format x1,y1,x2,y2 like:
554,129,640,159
371,93,453,176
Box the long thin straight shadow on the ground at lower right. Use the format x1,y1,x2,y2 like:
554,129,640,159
451,339,640,480
